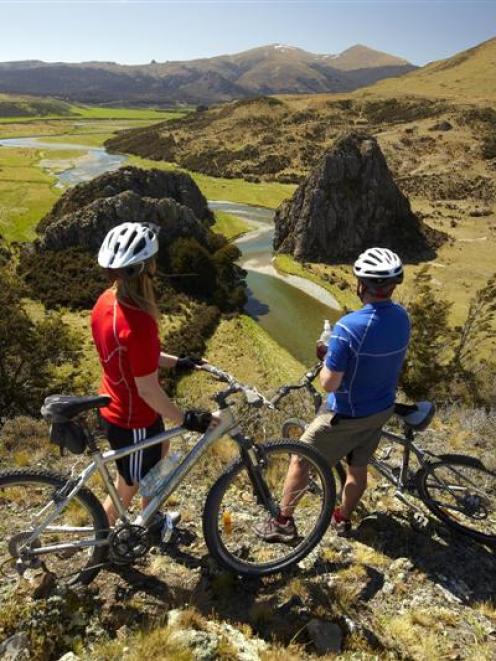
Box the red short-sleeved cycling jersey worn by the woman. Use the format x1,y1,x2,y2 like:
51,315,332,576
91,289,160,429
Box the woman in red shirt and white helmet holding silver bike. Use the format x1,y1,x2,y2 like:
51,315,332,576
91,223,212,525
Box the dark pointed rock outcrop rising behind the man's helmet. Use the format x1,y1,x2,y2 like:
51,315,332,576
274,131,444,263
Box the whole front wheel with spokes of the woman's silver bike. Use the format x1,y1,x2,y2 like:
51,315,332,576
203,440,336,576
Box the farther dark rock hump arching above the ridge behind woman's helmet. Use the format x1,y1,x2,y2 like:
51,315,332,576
37,167,213,233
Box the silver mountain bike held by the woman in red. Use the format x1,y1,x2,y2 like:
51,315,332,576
0,365,336,584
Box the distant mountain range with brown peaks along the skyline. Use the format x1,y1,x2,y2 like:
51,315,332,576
0,44,415,105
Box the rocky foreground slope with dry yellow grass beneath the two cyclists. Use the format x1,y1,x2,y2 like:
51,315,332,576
0,310,496,661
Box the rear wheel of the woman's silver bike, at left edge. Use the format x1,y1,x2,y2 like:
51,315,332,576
0,470,109,585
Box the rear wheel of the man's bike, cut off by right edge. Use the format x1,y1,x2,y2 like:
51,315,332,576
418,457,496,544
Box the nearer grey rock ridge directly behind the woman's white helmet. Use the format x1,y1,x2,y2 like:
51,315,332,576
37,191,208,253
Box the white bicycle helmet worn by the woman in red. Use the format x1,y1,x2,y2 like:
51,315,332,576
98,223,158,269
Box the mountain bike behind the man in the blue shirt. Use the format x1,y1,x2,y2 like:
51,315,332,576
279,363,496,545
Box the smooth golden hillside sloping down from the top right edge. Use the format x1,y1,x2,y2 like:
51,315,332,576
363,37,496,102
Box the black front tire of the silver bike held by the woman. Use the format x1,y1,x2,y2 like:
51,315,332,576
203,440,336,577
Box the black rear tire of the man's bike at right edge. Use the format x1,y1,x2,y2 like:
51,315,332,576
417,456,496,545
